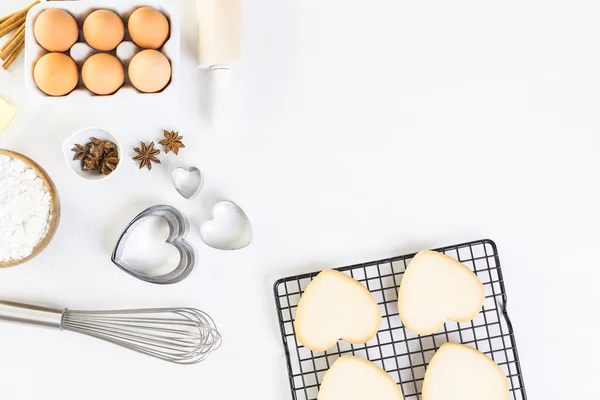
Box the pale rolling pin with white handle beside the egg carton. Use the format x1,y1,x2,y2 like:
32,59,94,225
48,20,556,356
196,0,242,130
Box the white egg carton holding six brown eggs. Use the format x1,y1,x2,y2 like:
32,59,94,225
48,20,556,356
25,0,181,105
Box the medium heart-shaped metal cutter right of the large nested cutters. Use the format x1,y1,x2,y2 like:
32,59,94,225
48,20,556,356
200,201,252,250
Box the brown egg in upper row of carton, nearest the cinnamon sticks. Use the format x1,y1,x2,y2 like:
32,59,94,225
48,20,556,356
33,8,79,51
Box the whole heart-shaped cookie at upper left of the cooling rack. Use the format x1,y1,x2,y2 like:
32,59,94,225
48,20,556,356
294,269,381,351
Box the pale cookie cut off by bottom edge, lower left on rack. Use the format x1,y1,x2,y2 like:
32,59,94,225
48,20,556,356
317,356,404,400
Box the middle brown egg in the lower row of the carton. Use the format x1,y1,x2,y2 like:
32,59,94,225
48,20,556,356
81,53,125,95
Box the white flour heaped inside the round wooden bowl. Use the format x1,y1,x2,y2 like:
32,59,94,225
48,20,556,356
0,155,50,262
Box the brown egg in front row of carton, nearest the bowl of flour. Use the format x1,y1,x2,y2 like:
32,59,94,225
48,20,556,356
33,53,79,96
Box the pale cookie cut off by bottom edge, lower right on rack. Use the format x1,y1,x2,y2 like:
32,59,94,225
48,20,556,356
423,343,508,400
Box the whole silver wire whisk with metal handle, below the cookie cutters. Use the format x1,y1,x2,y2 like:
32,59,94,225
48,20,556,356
0,301,222,364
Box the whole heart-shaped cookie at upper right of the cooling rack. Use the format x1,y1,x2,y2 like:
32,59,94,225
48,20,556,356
398,250,485,335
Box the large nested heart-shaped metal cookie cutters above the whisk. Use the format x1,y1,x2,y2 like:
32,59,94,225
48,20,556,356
111,205,196,285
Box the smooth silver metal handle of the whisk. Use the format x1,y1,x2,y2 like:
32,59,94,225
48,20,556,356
0,301,63,329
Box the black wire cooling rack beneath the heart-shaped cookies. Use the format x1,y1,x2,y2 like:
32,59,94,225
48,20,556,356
274,240,527,400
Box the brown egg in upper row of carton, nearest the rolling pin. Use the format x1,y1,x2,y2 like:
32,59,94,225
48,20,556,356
127,7,169,49
